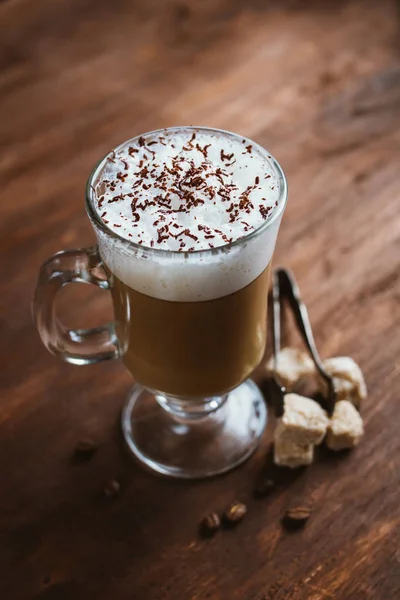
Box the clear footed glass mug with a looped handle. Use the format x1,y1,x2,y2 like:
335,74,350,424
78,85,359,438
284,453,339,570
33,127,287,478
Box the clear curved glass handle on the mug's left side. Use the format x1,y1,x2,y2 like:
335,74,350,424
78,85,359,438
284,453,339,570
32,246,120,365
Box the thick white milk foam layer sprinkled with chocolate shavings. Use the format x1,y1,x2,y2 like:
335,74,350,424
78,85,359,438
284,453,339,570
91,128,286,302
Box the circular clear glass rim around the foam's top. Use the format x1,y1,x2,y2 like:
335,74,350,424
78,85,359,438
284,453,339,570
85,125,288,258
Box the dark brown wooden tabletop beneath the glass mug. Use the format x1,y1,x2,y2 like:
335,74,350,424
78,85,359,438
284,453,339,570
0,0,400,600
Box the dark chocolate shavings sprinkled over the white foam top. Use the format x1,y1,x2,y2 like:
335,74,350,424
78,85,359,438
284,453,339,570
97,132,278,251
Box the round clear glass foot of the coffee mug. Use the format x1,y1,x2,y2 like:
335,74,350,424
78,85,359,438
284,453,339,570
122,379,267,479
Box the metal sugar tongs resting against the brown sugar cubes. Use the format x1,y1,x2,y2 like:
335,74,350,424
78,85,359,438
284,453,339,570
269,268,337,417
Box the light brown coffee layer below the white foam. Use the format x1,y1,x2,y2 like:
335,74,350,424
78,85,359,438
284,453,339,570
112,265,270,397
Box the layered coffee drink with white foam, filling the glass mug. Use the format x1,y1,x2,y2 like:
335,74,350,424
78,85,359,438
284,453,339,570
92,127,284,397
